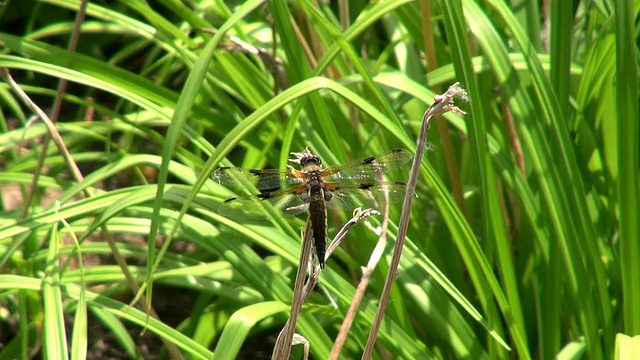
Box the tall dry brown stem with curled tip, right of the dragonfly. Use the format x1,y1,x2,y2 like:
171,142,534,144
362,83,467,359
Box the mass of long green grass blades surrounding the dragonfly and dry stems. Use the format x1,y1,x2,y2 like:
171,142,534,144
0,0,640,359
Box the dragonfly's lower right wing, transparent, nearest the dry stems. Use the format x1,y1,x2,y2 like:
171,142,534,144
325,182,406,211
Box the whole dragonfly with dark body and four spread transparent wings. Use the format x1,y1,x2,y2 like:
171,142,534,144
211,148,413,268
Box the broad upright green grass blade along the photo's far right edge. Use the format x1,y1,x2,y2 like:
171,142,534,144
615,0,640,334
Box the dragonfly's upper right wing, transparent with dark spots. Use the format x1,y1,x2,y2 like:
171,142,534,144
322,149,413,184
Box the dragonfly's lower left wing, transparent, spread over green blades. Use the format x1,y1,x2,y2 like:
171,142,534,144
218,191,309,220
